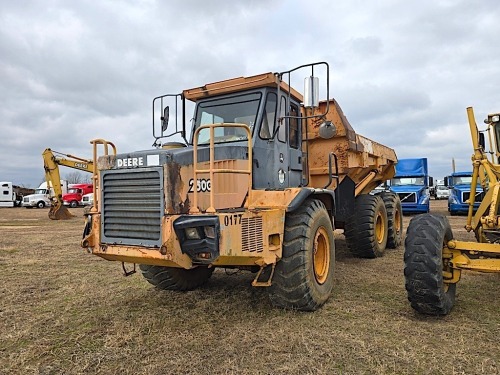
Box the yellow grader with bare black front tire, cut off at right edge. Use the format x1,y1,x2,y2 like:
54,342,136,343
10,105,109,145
404,107,500,315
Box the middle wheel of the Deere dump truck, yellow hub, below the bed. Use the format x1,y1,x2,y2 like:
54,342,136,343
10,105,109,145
344,194,388,258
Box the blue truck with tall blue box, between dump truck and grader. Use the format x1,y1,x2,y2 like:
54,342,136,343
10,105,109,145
391,158,432,214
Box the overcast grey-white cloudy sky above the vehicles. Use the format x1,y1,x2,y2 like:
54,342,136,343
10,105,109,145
0,0,500,187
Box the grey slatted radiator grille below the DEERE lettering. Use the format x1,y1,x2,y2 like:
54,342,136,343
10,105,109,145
102,169,162,246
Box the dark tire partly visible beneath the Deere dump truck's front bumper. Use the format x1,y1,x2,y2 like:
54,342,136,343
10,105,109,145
139,264,214,291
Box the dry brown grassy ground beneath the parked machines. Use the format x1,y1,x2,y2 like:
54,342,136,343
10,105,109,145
0,201,500,374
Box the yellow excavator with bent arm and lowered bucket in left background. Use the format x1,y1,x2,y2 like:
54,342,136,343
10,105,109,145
42,139,116,220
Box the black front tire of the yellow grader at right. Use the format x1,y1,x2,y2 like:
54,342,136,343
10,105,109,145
404,214,456,315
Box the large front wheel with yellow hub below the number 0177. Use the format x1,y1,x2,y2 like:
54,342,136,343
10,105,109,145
269,200,335,311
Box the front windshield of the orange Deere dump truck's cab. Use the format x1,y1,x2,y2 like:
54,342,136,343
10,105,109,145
194,92,262,144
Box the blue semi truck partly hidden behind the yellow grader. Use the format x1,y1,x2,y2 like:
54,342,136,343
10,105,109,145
445,171,484,215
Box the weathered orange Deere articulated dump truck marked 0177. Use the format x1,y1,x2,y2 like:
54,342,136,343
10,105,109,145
82,62,402,310
